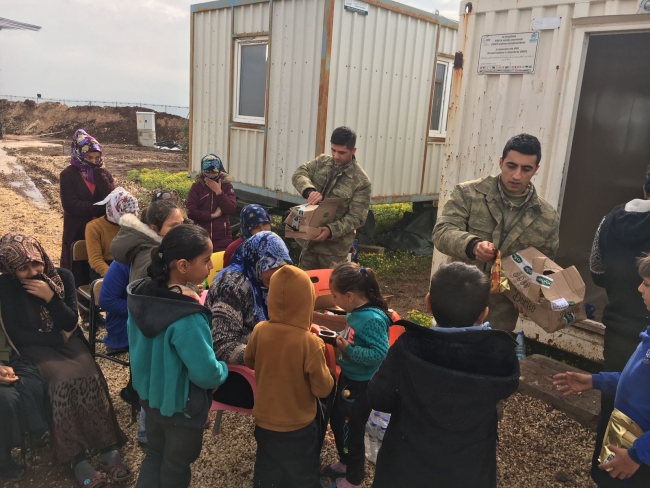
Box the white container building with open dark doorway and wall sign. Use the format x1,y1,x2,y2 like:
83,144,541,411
434,0,650,359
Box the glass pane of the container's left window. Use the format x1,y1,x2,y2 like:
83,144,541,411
239,44,266,117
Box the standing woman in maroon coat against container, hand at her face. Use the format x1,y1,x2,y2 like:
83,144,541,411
186,153,237,252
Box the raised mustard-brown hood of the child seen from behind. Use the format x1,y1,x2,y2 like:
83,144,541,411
267,265,314,330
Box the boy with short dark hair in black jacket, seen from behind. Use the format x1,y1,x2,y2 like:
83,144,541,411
368,262,519,488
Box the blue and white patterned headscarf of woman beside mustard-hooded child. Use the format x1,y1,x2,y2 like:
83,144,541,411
215,230,293,322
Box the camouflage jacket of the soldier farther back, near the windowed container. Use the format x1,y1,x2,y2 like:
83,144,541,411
291,154,372,256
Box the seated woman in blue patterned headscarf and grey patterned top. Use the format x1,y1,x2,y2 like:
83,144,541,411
205,231,293,408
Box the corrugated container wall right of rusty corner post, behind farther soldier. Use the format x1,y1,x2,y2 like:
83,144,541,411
327,0,438,197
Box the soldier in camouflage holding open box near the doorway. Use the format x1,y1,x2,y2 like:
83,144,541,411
433,134,560,331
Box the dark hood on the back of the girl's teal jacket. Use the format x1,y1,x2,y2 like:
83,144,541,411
126,278,210,338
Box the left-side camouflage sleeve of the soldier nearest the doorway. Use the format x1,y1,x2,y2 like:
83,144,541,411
433,185,477,260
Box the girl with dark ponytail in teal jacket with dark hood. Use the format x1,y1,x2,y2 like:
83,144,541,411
127,225,228,488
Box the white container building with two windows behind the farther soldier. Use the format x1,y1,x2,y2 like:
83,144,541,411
189,0,458,206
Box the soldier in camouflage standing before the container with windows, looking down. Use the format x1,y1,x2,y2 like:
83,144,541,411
291,127,371,270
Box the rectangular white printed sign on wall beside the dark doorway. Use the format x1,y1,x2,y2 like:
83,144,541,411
477,32,539,75
